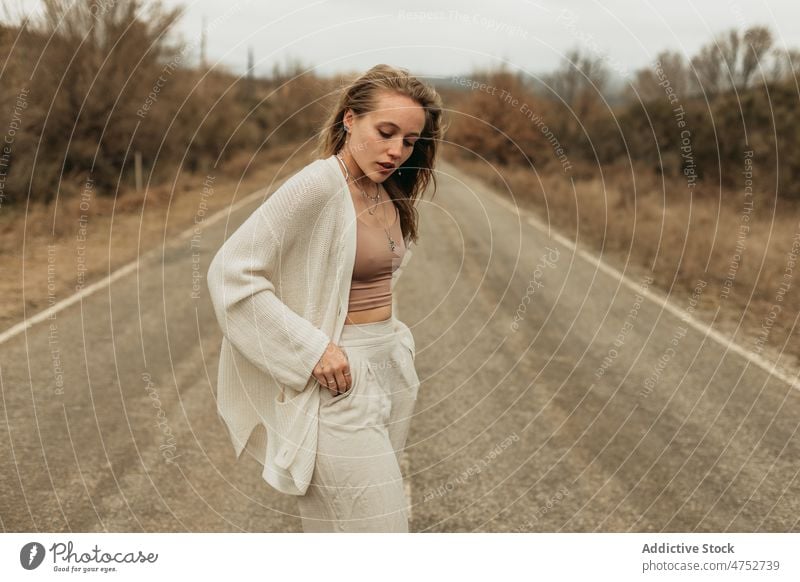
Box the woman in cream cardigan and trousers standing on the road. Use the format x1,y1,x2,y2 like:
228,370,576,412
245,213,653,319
208,65,443,532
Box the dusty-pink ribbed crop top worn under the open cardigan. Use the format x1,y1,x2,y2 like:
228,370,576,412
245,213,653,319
348,202,406,311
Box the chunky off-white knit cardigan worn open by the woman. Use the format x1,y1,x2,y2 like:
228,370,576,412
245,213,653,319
207,156,416,495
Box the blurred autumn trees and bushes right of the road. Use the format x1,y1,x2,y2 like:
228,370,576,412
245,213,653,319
448,26,800,198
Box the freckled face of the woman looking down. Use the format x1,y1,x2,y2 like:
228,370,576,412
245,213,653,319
344,91,425,183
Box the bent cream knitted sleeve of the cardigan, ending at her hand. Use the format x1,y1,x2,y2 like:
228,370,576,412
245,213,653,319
207,169,330,391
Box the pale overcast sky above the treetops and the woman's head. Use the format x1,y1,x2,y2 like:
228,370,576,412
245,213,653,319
130,0,800,77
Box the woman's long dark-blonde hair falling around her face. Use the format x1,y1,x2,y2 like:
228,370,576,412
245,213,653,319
316,64,445,242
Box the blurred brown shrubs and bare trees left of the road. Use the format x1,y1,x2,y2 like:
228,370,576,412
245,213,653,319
0,0,332,204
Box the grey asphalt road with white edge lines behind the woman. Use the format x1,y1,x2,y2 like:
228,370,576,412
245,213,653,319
0,164,800,532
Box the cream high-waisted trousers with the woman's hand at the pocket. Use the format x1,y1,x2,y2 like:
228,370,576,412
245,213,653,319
297,318,419,532
